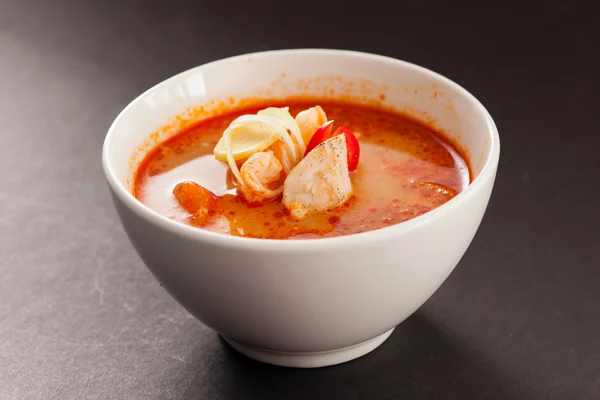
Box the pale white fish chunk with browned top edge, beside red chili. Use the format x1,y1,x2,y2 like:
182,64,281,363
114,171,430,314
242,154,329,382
282,135,352,219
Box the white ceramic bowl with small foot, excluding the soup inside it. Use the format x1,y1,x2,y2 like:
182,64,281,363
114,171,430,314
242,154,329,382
102,50,500,367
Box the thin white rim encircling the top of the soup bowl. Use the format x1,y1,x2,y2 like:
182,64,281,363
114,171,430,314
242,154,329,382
102,48,500,251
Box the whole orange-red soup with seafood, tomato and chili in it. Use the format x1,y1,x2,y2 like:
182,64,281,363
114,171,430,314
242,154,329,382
133,100,471,239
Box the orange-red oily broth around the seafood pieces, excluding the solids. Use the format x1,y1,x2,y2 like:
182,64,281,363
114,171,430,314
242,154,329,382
133,101,471,239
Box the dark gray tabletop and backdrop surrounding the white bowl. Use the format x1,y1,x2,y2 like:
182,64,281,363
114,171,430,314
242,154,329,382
0,0,600,400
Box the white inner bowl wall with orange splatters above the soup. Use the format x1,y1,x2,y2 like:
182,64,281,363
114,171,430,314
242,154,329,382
104,50,497,196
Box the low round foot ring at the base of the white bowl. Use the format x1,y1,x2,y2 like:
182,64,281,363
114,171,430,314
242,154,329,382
222,328,395,368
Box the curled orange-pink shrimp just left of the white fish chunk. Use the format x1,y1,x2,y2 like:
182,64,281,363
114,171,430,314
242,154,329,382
238,151,283,203
